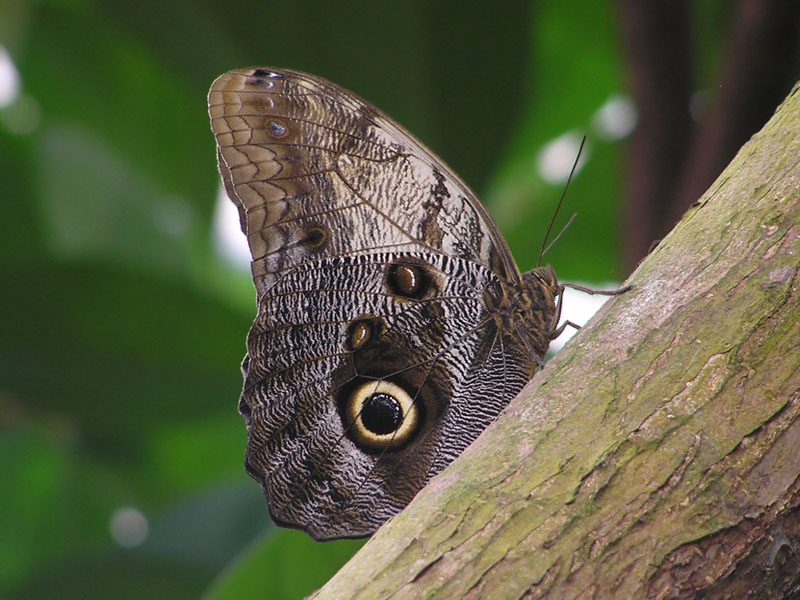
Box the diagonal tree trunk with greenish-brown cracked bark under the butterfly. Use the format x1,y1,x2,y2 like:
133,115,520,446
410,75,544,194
314,81,800,600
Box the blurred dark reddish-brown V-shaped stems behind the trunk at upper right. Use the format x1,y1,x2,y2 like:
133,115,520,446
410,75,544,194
620,0,800,267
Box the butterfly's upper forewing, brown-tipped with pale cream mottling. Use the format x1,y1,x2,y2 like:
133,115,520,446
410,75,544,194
209,69,519,293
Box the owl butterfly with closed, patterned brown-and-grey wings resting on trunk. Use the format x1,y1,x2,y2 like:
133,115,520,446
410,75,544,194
208,68,624,540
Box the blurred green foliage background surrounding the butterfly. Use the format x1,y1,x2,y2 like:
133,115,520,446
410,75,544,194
0,0,732,598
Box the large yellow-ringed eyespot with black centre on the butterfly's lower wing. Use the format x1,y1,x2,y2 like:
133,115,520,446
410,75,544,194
345,379,420,450
